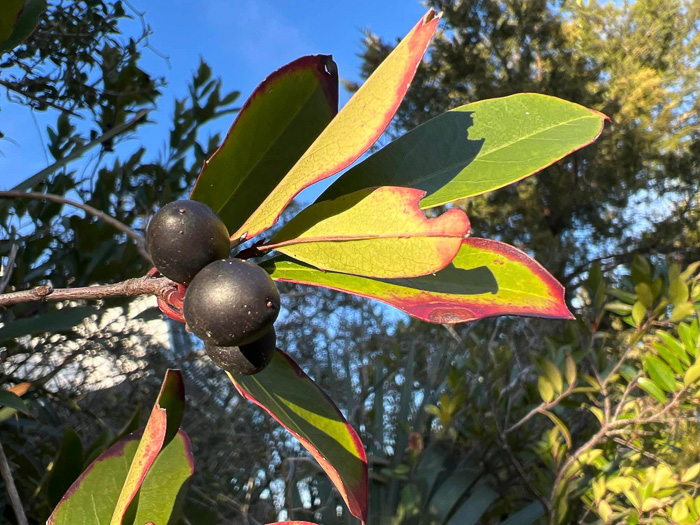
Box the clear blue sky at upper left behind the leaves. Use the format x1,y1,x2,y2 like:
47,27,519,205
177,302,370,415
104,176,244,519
0,0,426,189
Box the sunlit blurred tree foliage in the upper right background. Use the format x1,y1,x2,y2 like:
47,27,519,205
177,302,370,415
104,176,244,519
350,0,700,282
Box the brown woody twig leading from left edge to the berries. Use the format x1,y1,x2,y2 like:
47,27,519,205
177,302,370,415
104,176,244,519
0,276,177,306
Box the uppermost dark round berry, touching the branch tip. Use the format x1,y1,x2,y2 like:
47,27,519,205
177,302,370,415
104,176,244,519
146,200,230,284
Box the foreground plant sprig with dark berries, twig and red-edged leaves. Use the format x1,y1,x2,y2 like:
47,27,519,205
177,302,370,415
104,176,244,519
0,10,606,524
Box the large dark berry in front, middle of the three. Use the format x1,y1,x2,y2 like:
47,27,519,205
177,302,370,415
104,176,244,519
183,259,280,346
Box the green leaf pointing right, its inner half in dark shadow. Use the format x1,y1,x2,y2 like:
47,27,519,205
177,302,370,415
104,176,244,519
320,93,606,208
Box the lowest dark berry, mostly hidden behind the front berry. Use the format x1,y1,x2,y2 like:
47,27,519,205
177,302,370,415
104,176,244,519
204,328,277,376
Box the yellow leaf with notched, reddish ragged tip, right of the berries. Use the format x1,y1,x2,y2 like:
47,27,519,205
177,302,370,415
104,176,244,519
264,186,469,278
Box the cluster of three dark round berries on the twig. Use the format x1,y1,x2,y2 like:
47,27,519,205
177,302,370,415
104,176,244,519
146,200,280,375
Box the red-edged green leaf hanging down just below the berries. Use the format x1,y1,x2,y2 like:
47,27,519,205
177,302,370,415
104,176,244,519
228,350,368,520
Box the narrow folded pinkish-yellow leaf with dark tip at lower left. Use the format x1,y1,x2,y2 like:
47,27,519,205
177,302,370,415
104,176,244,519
110,369,185,525
